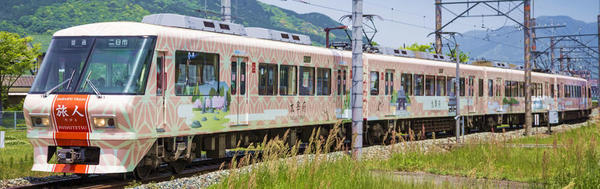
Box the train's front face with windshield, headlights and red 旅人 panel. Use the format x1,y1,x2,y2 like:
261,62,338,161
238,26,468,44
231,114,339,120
23,36,157,174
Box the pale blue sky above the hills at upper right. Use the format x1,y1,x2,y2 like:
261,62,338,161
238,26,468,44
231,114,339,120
258,0,600,47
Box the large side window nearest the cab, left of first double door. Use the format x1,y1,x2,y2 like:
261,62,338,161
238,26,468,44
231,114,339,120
175,51,219,96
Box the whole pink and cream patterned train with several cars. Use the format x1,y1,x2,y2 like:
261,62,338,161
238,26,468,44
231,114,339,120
23,14,592,178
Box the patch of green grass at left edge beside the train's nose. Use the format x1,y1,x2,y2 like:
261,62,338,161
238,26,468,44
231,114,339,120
0,128,60,179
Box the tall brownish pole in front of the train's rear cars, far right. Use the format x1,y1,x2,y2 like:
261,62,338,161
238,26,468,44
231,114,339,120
523,0,532,136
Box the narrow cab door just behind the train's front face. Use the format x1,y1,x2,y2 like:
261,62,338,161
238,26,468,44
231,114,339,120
155,52,167,132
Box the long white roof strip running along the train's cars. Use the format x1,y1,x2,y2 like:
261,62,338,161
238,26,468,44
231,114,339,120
53,21,586,81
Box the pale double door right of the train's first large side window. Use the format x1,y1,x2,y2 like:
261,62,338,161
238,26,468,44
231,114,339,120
230,57,249,125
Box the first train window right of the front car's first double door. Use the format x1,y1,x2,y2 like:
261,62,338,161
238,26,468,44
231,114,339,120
258,63,278,95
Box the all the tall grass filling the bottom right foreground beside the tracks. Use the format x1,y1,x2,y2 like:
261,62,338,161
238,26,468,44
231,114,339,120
211,124,600,188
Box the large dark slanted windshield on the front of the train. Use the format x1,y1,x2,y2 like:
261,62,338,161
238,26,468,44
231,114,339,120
30,37,155,94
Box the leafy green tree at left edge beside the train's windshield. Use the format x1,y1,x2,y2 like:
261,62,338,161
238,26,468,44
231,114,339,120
0,31,40,113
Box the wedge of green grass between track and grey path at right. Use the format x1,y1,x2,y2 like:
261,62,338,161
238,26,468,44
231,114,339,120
369,121,600,188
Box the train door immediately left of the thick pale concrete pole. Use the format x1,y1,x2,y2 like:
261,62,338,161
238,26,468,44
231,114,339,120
335,66,350,119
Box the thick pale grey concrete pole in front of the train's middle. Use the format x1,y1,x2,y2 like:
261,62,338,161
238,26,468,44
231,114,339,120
350,0,363,160
